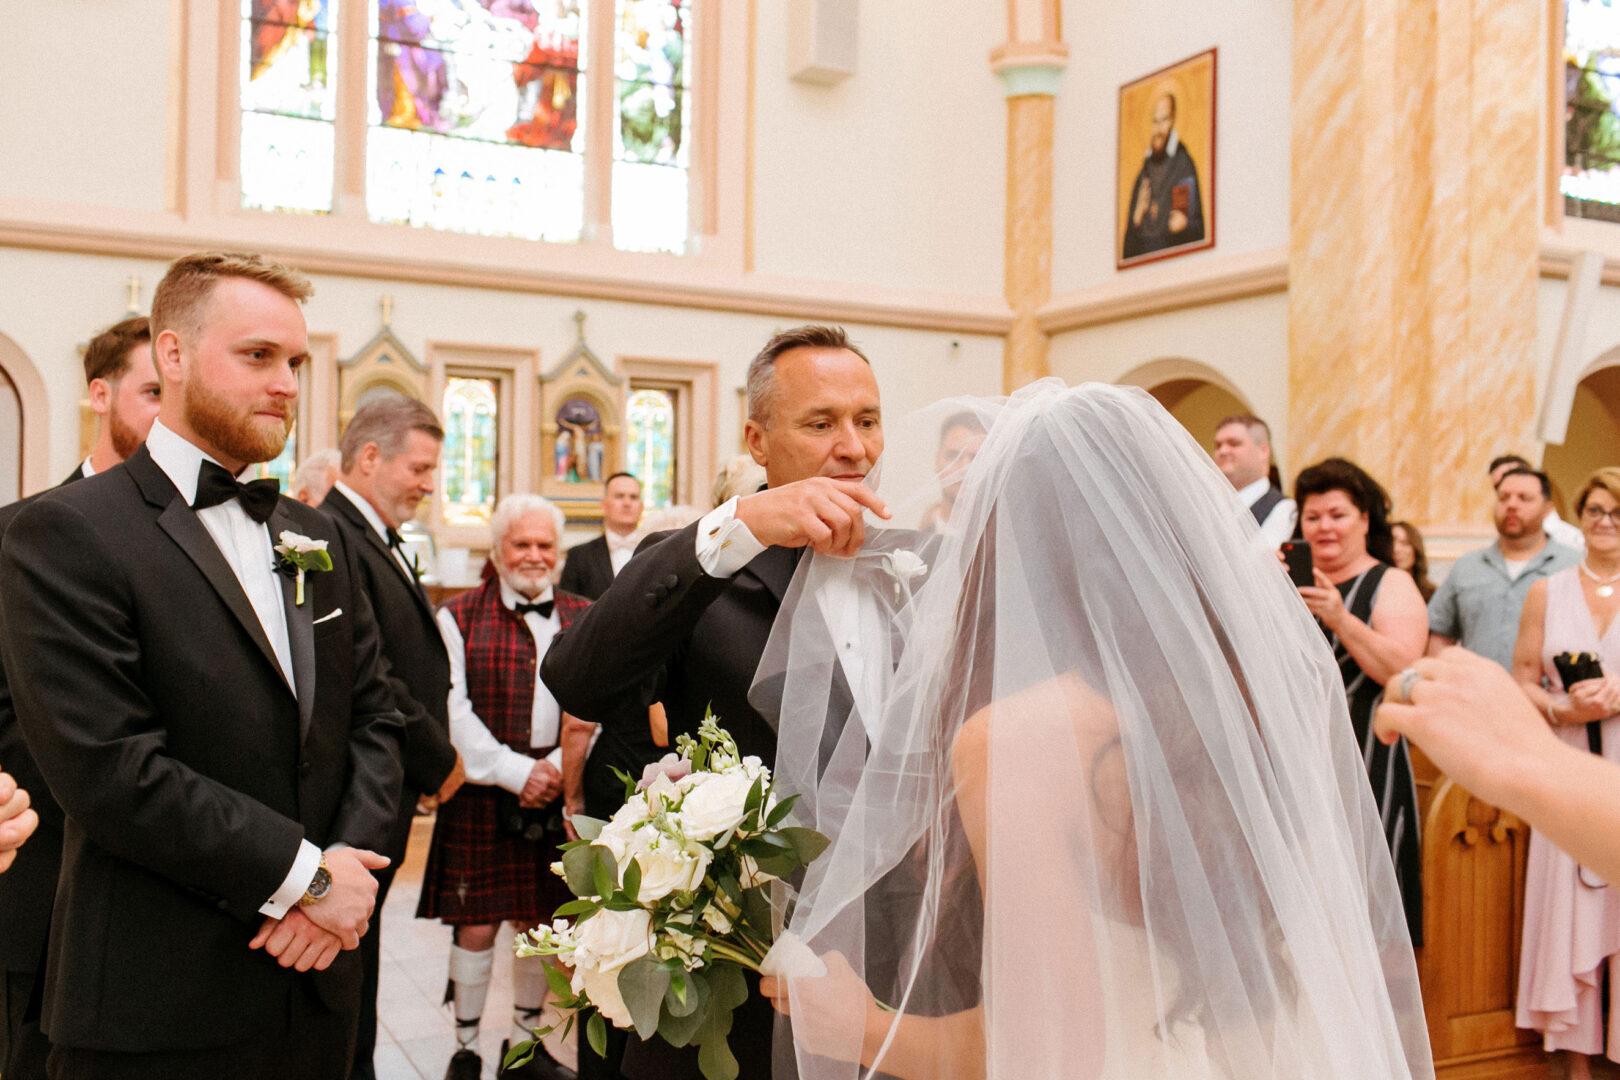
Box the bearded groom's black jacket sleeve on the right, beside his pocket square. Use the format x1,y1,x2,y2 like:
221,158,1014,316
327,533,405,854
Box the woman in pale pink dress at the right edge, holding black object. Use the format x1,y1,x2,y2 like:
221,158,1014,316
1513,468,1620,1080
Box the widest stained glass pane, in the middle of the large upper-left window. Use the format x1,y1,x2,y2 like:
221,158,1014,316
366,0,586,241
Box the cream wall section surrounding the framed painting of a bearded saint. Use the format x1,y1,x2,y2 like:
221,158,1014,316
1051,0,1293,295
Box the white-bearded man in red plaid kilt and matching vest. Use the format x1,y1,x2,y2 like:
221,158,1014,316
416,495,588,1080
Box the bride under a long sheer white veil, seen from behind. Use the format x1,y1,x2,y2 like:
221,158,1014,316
752,379,1434,1080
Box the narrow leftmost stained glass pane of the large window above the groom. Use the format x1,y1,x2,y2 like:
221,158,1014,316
241,0,337,212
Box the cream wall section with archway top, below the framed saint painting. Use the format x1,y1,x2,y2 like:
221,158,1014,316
1051,293,1307,476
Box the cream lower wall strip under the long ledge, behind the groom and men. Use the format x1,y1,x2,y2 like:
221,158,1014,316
0,248,1001,492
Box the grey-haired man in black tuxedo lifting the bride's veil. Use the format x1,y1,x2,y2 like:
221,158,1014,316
541,325,888,1080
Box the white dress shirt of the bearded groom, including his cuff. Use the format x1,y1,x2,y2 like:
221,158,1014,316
146,419,321,918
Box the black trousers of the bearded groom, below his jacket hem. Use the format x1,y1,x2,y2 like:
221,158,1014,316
45,983,355,1080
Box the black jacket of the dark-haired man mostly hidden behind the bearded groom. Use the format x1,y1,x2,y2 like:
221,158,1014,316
0,465,84,973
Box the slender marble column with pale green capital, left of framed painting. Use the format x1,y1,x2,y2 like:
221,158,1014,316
990,28,1069,393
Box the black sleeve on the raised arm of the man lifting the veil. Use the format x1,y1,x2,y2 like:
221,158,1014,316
539,521,731,724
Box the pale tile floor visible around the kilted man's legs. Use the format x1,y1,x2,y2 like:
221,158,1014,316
373,818,573,1080
